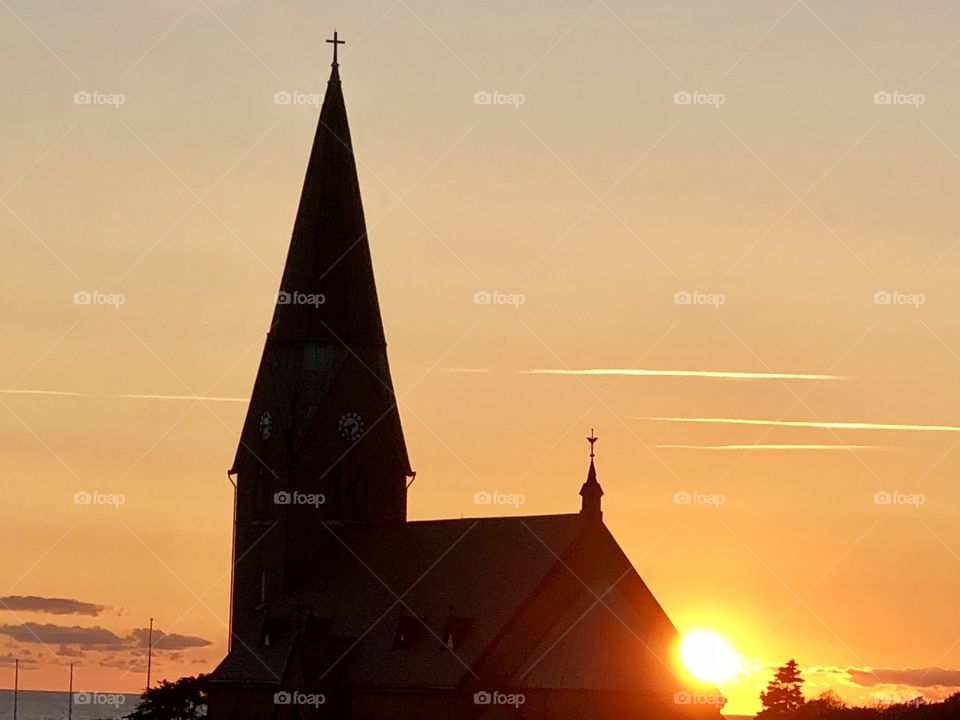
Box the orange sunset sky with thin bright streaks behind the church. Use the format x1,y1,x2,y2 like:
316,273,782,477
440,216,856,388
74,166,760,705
0,0,960,713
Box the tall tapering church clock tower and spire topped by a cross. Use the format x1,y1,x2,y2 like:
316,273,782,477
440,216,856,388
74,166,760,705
232,34,411,629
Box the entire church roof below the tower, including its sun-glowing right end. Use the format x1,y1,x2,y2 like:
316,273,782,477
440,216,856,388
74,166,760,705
213,506,676,692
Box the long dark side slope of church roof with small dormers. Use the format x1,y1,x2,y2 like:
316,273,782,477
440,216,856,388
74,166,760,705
214,514,584,687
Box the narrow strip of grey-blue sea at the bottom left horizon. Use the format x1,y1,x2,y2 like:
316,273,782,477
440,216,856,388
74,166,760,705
0,690,140,720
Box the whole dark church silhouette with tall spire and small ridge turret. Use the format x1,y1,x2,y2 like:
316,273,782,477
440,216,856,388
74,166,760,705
209,36,720,720
